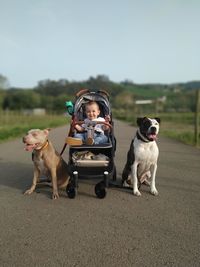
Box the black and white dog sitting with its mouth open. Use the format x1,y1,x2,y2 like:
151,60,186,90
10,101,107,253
122,117,160,196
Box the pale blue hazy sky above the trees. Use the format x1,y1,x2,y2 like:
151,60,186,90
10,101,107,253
0,0,200,88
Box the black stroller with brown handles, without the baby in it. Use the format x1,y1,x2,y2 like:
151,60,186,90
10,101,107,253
66,89,116,198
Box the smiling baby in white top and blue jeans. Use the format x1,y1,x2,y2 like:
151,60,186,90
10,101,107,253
66,101,109,145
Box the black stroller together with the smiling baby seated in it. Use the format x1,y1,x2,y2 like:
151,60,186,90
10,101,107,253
66,89,116,198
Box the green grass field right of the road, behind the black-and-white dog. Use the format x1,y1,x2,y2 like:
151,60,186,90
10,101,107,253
114,110,200,149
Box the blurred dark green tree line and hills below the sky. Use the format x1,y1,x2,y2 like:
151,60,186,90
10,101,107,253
0,75,200,112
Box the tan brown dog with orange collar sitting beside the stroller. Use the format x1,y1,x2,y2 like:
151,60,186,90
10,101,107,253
23,129,69,199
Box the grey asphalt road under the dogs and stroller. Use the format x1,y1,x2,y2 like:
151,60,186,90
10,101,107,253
0,121,200,267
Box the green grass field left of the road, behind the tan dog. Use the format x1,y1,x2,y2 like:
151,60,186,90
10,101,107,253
0,112,69,142
